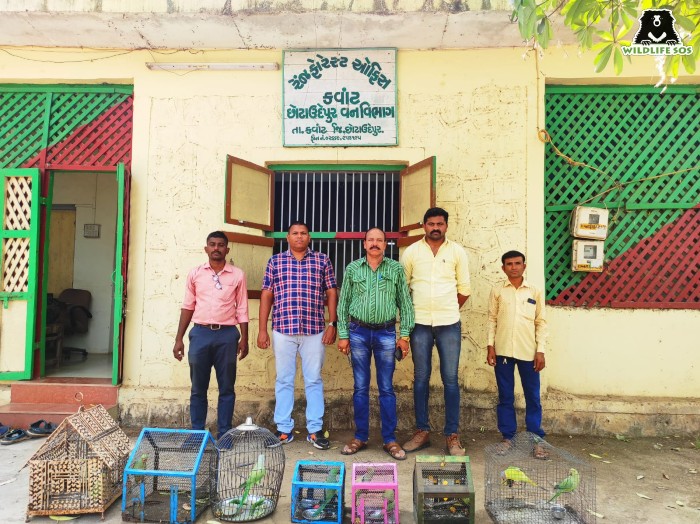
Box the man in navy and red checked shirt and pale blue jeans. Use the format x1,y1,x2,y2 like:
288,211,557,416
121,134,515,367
257,222,338,449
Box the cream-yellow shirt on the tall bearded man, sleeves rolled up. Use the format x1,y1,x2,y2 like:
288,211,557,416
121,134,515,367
401,237,471,326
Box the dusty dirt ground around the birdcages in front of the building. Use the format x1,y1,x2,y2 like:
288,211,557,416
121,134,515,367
0,431,700,524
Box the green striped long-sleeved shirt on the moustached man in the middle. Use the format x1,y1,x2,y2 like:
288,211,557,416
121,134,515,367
338,257,415,338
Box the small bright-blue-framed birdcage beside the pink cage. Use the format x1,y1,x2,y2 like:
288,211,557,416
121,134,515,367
292,460,345,524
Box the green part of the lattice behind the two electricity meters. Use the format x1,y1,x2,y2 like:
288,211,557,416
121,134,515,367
545,87,700,300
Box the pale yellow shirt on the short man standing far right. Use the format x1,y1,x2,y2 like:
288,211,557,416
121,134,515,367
488,280,547,360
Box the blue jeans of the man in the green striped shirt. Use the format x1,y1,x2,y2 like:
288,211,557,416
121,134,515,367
350,322,396,444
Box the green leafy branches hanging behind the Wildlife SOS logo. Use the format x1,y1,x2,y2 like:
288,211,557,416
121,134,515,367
510,0,700,78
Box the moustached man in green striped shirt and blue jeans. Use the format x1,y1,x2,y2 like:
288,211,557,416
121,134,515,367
338,228,415,460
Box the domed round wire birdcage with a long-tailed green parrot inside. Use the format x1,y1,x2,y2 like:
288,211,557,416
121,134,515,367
212,417,285,522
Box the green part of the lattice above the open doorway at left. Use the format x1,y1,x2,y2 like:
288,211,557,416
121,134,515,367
0,85,130,168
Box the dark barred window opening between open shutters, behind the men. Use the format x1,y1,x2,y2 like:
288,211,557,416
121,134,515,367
272,166,400,285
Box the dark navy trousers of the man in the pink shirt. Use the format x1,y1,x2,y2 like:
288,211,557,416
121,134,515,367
187,325,241,438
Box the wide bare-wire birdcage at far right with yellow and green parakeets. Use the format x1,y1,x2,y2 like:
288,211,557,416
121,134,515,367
484,433,596,524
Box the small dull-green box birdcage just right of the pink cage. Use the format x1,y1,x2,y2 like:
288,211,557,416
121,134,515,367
413,455,475,524
